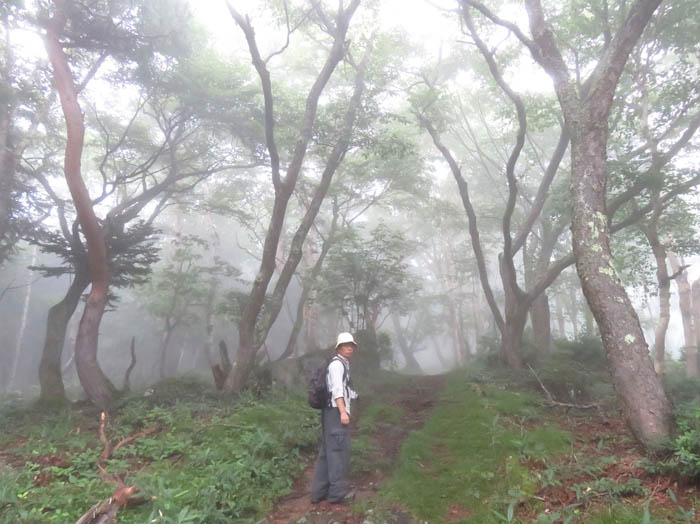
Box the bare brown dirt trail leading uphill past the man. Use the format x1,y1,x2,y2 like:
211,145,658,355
264,375,445,524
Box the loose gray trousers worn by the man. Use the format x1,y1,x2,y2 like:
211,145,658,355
311,408,350,502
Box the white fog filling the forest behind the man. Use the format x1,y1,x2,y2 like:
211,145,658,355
0,0,700,406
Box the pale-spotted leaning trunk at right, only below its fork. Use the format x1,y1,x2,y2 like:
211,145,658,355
572,126,673,448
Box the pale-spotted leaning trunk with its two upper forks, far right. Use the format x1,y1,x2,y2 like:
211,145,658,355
519,0,673,449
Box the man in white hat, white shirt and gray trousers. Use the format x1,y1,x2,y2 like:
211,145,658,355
311,333,357,504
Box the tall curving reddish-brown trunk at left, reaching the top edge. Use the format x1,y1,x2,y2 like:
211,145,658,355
45,0,116,409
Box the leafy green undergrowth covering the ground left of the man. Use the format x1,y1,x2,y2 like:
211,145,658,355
0,381,318,524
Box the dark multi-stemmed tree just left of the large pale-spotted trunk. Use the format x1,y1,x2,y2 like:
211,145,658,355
413,52,573,369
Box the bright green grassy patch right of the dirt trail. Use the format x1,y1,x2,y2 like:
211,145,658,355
385,374,570,523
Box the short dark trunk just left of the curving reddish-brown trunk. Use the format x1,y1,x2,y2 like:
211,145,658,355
39,270,90,404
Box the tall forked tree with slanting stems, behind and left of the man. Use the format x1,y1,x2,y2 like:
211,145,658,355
226,0,363,392
